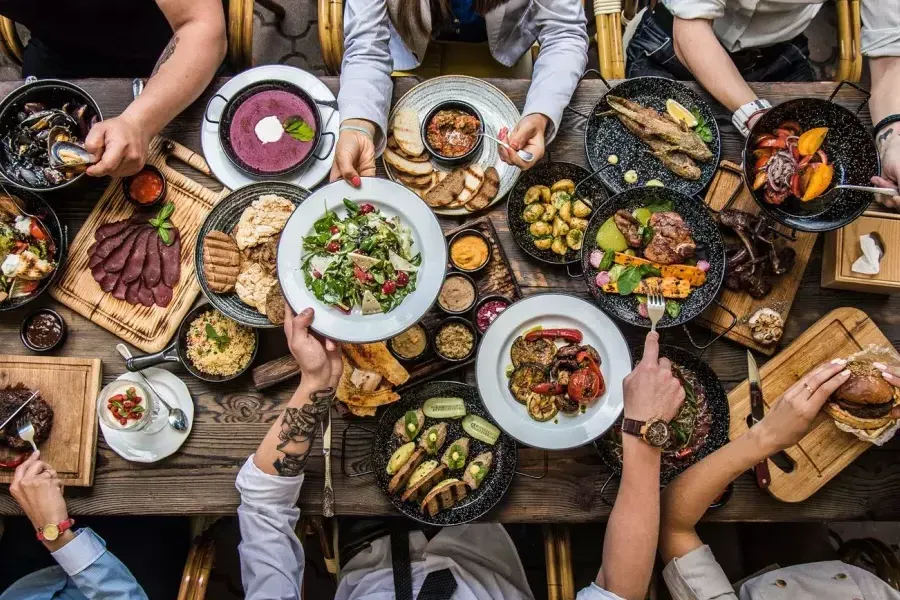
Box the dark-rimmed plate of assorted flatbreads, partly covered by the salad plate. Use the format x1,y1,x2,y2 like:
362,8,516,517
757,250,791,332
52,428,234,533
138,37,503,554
194,182,310,328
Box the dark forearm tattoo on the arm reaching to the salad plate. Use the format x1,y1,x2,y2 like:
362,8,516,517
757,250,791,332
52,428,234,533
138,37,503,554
272,388,334,477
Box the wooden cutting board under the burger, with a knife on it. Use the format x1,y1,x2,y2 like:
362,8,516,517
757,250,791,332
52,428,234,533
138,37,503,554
728,307,891,502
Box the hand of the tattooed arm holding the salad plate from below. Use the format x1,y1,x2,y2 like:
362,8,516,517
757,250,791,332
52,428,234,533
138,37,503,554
284,302,344,390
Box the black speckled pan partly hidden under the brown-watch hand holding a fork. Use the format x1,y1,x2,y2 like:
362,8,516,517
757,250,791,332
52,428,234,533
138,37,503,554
594,346,730,485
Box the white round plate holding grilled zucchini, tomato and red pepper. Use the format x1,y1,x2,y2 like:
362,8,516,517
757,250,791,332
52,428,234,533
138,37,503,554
475,294,631,450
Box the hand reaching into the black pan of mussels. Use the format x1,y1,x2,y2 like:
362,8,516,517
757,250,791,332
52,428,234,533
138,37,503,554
84,114,153,177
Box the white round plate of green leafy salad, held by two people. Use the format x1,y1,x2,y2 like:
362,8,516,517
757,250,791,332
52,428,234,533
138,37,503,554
278,177,447,344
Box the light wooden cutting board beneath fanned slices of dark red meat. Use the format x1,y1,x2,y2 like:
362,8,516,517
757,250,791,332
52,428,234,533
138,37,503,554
50,137,230,352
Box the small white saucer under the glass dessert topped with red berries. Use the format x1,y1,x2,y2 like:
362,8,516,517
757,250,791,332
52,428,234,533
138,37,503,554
98,367,194,463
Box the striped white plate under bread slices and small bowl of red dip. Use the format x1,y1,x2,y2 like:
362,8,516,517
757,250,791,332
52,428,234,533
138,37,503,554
385,75,522,215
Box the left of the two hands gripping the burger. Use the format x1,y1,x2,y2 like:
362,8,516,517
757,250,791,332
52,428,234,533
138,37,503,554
751,358,850,454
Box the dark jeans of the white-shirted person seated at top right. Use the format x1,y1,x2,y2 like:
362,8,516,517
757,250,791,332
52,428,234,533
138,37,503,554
626,10,815,81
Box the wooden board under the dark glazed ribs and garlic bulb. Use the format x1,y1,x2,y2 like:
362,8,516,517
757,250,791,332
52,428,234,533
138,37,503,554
697,160,816,355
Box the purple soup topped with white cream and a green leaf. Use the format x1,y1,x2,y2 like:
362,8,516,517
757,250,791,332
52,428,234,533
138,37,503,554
229,90,316,173
